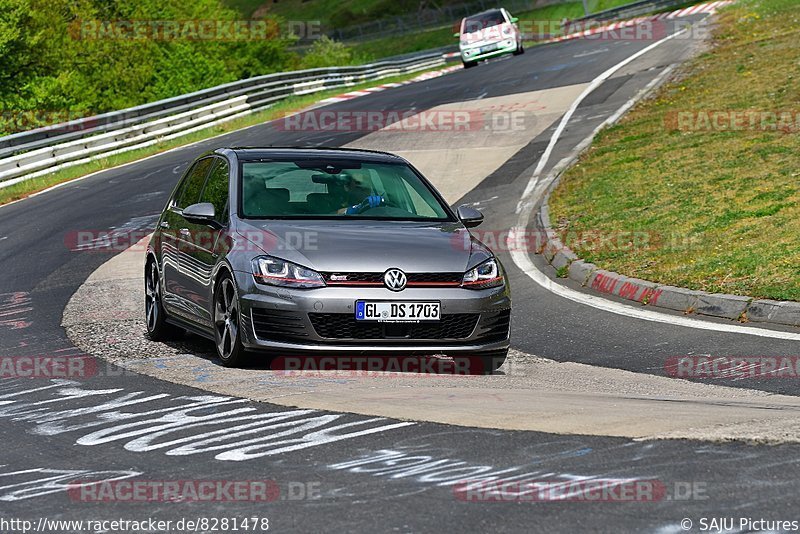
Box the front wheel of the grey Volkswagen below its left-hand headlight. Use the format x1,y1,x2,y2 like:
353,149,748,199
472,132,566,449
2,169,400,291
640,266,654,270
214,273,247,367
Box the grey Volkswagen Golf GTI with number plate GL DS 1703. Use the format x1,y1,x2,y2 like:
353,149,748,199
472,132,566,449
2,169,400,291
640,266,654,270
145,148,511,372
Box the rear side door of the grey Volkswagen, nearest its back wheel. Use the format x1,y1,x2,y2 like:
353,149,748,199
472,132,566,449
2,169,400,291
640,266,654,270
161,157,214,320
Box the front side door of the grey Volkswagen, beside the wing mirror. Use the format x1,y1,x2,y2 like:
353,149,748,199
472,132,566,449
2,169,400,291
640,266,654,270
178,157,230,327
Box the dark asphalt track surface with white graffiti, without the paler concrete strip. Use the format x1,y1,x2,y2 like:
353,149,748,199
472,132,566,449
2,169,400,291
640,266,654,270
0,12,800,533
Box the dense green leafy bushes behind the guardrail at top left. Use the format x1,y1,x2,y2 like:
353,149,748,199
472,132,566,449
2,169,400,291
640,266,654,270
0,0,297,132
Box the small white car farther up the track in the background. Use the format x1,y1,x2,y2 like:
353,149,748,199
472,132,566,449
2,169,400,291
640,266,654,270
454,8,525,69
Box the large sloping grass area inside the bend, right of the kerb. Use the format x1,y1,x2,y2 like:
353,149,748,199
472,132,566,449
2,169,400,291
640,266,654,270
550,0,800,300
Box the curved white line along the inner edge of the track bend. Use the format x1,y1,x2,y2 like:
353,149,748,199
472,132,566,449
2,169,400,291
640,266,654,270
508,25,800,341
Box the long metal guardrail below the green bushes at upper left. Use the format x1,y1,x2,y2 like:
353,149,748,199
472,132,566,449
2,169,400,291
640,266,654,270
0,53,445,188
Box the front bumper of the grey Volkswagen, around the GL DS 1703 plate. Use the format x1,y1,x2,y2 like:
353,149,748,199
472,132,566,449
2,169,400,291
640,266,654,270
231,272,511,355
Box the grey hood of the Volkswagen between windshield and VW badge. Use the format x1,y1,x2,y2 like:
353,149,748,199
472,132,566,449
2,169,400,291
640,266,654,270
237,220,492,273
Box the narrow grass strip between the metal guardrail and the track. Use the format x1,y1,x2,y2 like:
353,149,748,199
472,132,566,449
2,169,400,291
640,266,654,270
0,67,441,205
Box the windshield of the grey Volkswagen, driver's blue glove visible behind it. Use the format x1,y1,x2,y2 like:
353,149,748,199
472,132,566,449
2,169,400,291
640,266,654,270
239,160,451,220
